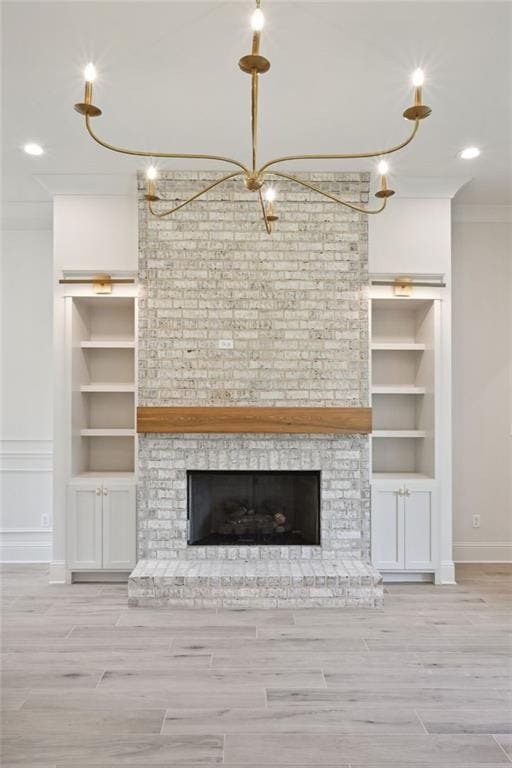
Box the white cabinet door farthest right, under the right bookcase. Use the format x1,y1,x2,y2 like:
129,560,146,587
404,488,435,570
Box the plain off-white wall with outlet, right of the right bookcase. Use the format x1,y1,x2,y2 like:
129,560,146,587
453,222,512,561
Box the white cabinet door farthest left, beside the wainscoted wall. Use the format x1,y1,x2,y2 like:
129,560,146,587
67,485,103,569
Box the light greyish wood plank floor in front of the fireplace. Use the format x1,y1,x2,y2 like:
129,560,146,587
1,566,512,768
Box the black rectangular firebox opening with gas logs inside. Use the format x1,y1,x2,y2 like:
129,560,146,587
187,470,320,546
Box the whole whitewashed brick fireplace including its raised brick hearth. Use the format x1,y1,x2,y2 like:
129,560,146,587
129,172,382,607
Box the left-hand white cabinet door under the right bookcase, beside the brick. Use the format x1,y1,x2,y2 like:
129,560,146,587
372,486,404,571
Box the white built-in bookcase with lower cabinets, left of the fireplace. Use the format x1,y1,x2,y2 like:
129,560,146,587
65,289,137,578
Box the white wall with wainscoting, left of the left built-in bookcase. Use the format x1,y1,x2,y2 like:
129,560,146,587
0,230,52,562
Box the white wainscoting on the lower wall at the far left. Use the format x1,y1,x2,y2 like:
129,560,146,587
0,439,52,563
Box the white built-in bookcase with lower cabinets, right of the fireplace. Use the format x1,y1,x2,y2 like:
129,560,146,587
370,292,441,578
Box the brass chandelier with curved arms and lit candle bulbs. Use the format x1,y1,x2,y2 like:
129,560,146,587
75,0,431,234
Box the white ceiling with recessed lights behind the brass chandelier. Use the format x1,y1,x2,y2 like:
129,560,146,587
2,0,512,210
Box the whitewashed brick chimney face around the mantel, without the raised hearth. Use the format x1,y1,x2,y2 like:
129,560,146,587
138,172,369,559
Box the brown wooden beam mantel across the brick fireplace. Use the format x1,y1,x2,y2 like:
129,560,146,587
137,406,372,435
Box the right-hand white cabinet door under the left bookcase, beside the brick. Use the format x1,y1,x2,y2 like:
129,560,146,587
103,483,136,571
